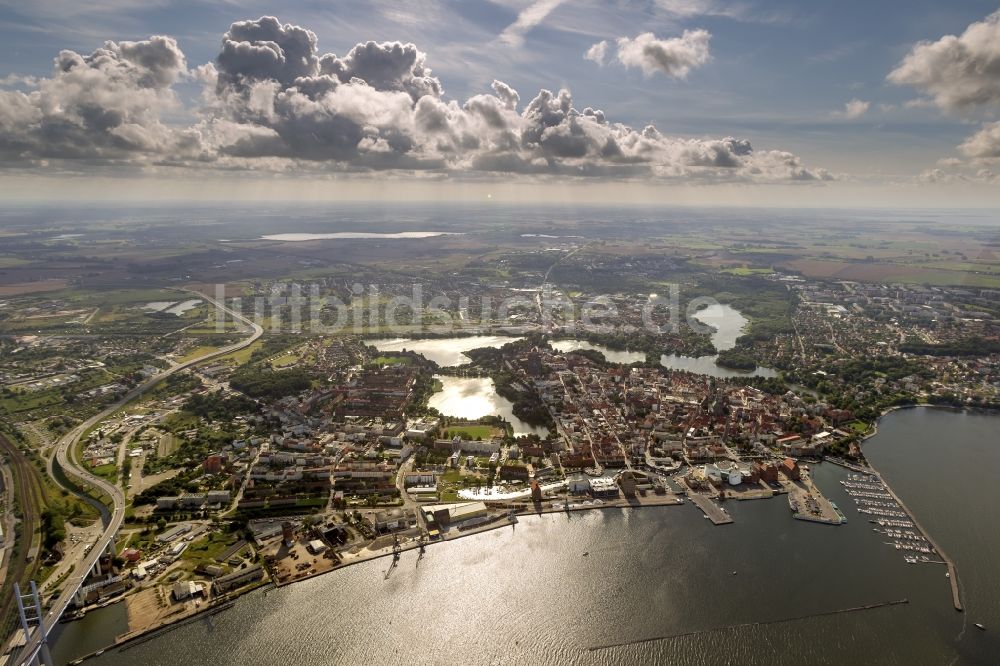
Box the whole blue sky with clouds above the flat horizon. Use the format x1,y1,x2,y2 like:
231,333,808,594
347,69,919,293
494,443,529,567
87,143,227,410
0,0,1000,207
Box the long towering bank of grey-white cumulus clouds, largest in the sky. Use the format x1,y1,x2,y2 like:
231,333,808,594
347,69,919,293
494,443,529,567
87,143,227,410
0,17,832,182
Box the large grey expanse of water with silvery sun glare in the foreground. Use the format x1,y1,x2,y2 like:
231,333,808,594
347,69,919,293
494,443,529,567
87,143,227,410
57,405,998,666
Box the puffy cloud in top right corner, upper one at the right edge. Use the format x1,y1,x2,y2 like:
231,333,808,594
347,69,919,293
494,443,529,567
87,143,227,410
889,12,1000,112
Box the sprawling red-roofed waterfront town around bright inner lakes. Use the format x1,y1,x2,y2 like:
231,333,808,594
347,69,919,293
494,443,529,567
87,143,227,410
0,218,1000,651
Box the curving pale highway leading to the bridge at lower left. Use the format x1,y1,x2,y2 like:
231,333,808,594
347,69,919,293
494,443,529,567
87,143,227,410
14,292,264,664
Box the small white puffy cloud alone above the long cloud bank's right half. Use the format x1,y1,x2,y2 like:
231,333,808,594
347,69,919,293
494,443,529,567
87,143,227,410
618,30,712,79
